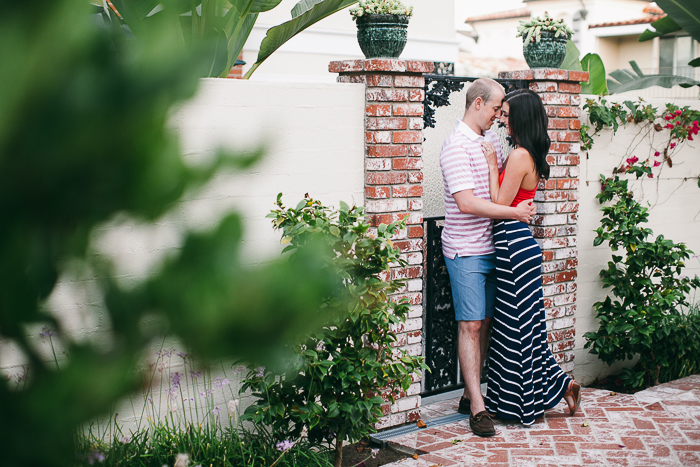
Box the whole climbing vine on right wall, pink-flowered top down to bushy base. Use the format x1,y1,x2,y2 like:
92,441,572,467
581,98,700,387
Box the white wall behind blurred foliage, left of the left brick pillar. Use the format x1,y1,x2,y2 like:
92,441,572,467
0,79,365,428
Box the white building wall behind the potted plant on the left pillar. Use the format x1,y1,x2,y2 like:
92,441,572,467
243,0,458,82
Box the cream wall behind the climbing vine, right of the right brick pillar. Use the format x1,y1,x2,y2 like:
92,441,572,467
574,96,700,384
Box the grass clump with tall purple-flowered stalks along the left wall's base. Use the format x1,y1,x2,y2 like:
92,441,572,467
76,349,335,467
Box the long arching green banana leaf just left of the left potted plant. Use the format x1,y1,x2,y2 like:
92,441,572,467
244,0,357,79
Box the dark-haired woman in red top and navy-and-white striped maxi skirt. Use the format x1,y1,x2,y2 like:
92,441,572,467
482,89,581,425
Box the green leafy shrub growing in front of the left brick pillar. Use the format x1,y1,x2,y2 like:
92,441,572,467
243,194,427,467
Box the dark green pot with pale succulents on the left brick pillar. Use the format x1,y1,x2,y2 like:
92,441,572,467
350,0,413,58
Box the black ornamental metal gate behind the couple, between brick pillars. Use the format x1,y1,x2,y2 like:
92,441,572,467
421,75,528,396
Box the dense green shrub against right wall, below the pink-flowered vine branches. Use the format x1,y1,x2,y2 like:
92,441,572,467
584,168,700,387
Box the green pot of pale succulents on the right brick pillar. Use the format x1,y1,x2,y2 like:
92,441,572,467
516,11,574,68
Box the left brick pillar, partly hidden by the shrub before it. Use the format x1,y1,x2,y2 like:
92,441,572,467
329,59,434,428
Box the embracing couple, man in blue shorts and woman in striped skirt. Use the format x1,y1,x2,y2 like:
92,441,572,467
440,78,581,436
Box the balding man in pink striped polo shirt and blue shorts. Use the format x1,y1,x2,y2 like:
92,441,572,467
440,78,537,436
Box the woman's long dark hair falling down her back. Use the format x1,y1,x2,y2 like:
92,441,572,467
503,89,552,179
